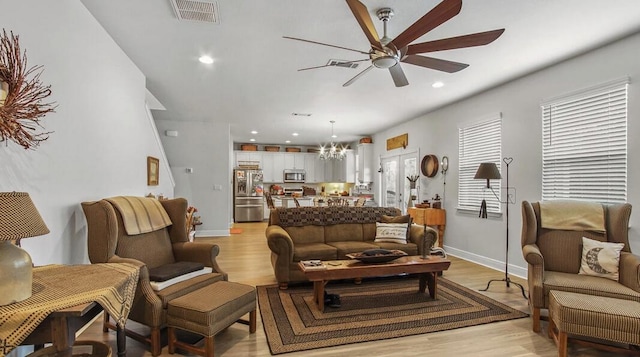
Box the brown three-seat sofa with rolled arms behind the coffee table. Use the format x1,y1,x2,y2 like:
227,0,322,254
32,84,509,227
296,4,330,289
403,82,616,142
266,206,438,289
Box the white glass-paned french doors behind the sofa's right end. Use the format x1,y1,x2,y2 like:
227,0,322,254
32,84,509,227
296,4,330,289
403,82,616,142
380,151,419,213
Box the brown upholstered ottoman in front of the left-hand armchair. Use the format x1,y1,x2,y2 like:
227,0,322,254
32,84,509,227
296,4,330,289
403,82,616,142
167,281,256,357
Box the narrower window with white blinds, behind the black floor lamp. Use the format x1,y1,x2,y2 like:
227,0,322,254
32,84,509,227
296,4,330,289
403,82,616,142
458,113,502,213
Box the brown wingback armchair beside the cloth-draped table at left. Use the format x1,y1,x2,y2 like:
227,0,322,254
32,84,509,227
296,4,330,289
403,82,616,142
82,197,227,356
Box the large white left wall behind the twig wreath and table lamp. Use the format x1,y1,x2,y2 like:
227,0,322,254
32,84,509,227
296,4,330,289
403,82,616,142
0,0,173,265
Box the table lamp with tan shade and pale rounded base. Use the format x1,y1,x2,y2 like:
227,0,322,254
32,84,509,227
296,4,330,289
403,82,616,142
0,192,49,306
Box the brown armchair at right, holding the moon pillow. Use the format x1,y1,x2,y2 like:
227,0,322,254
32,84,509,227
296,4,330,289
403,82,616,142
521,201,640,332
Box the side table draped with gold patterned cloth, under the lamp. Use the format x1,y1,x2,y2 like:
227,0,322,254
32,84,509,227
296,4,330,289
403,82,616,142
0,264,139,357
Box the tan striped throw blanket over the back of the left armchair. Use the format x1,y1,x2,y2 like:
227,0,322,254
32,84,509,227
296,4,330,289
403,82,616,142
106,196,172,236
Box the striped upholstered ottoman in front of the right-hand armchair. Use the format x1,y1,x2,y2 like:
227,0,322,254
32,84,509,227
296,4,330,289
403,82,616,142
548,290,640,357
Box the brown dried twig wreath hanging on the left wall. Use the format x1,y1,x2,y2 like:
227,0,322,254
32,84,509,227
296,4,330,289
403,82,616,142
0,29,55,149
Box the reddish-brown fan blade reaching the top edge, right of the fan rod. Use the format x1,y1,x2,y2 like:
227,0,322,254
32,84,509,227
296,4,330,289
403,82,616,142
391,0,462,48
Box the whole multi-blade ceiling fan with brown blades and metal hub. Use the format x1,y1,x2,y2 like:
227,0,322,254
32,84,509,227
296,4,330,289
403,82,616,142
284,0,504,87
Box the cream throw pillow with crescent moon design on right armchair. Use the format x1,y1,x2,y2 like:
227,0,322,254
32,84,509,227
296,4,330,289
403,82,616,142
578,237,624,281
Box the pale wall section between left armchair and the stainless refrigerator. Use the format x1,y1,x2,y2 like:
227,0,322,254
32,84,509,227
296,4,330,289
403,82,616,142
156,120,233,236
